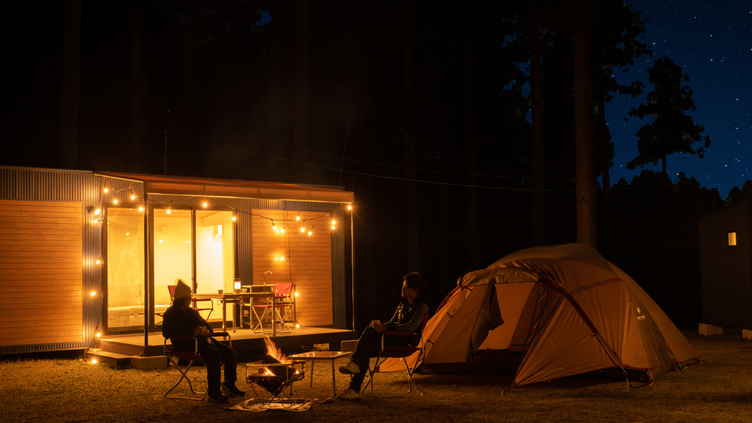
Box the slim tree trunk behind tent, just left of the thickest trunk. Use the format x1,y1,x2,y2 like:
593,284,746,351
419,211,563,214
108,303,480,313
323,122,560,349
530,0,546,246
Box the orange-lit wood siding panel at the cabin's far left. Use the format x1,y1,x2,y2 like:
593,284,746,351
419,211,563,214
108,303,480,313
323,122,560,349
0,200,83,346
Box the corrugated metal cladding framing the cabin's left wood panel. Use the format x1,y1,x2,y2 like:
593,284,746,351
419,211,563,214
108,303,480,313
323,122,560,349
0,167,103,354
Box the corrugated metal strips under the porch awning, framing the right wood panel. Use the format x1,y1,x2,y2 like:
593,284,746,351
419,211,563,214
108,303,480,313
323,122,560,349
149,195,352,329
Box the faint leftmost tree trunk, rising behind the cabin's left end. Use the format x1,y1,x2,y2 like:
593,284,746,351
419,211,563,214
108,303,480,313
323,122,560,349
58,0,82,169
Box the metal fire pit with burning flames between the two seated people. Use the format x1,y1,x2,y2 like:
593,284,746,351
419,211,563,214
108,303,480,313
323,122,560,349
245,356,305,404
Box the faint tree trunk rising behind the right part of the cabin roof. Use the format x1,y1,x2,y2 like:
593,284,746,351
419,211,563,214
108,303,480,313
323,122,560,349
293,0,312,183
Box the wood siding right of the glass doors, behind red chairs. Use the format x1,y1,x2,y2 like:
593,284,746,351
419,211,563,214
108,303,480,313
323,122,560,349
253,210,332,326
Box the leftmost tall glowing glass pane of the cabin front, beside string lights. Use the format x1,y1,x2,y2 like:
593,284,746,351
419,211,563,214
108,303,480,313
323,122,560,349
106,208,144,330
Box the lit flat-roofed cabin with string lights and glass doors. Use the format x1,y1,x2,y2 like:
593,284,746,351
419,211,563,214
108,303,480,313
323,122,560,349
0,167,357,362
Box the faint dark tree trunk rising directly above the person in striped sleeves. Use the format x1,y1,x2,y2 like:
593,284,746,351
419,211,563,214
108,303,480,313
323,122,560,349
402,0,420,272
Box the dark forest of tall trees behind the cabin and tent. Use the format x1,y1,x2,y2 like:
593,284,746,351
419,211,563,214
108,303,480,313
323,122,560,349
0,0,743,327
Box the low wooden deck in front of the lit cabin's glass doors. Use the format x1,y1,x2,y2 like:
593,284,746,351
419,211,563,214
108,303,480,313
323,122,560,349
99,327,359,357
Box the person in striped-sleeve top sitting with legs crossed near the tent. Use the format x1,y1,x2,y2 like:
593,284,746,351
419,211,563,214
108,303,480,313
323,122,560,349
337,272,428,400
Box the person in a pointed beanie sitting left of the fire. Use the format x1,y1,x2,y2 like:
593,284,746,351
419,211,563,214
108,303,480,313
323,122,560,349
162,279,245,403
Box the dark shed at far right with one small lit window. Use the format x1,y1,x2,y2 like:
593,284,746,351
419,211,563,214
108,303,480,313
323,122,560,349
698,195,752,329
